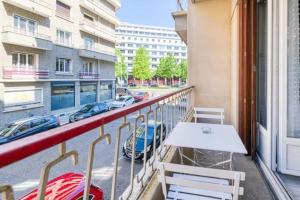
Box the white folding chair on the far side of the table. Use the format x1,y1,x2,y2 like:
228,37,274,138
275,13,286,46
194,107,225,168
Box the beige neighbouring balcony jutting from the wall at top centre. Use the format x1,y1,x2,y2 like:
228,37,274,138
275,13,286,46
172,0,187,44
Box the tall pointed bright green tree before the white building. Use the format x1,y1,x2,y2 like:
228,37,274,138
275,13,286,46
132,47,152,84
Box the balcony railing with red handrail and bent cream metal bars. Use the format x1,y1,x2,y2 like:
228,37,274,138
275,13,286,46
0,87,193,199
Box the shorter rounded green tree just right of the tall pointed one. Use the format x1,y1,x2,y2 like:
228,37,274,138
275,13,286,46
156,55,177,84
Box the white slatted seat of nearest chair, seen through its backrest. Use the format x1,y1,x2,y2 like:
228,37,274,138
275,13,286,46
167,173,232,200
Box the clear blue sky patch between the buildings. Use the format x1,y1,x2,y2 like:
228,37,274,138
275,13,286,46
117,0,176,28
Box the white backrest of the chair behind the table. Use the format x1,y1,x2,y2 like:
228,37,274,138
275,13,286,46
194,107,225,124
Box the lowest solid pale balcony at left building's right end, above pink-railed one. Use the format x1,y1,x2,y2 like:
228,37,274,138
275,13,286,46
79,46,116,62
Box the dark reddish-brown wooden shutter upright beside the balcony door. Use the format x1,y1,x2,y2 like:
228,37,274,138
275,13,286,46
238,0,257,156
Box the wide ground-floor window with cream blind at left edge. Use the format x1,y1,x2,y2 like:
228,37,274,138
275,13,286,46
3,87,43,111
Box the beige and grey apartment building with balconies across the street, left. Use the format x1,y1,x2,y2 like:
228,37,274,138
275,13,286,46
0,0,120,126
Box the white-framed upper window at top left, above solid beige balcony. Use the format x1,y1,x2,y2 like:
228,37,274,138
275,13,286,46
14,15,37,36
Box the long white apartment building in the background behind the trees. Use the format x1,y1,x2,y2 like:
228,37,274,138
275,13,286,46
116,23,187,74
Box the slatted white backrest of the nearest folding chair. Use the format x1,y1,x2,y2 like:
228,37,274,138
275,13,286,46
158,163,245,200
